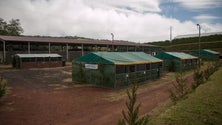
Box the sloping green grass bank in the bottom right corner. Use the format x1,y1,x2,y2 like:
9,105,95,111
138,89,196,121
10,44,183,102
149,68,222,125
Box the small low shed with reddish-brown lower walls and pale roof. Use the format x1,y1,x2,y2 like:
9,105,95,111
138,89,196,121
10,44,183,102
12,54,62,69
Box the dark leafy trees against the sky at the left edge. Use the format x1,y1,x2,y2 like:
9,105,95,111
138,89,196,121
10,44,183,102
0,18,23,36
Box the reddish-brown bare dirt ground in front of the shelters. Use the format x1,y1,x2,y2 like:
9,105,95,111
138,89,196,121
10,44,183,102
0,67,194,125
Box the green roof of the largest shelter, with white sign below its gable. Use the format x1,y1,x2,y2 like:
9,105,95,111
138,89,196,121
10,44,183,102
75,52,162,65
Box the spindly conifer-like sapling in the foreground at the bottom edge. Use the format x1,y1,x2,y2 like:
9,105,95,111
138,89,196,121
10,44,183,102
118,84,149,125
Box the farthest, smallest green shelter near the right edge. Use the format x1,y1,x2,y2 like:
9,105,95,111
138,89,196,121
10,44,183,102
192,49,220,61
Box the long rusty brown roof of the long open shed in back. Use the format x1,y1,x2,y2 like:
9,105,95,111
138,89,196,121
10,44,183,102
0,35,157,47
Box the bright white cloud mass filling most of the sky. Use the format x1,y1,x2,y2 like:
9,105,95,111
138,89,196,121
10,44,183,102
0,0,222,42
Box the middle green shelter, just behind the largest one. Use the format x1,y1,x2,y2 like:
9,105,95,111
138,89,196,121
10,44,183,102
155,52,198,72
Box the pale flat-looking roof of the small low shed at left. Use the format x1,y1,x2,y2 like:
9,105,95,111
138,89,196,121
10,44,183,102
16,53,62,58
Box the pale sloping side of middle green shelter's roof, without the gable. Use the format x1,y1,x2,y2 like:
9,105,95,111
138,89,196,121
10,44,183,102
165,52,197,60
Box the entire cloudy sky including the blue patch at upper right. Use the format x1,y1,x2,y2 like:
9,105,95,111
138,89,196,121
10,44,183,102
0,0,222,42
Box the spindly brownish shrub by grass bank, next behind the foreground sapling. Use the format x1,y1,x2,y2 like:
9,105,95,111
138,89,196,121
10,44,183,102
169,72,187,102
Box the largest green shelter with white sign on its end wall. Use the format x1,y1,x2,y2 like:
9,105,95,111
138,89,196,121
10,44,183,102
72,52,162,88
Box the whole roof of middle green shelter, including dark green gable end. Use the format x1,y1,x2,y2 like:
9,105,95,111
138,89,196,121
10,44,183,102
155,52,197,60
